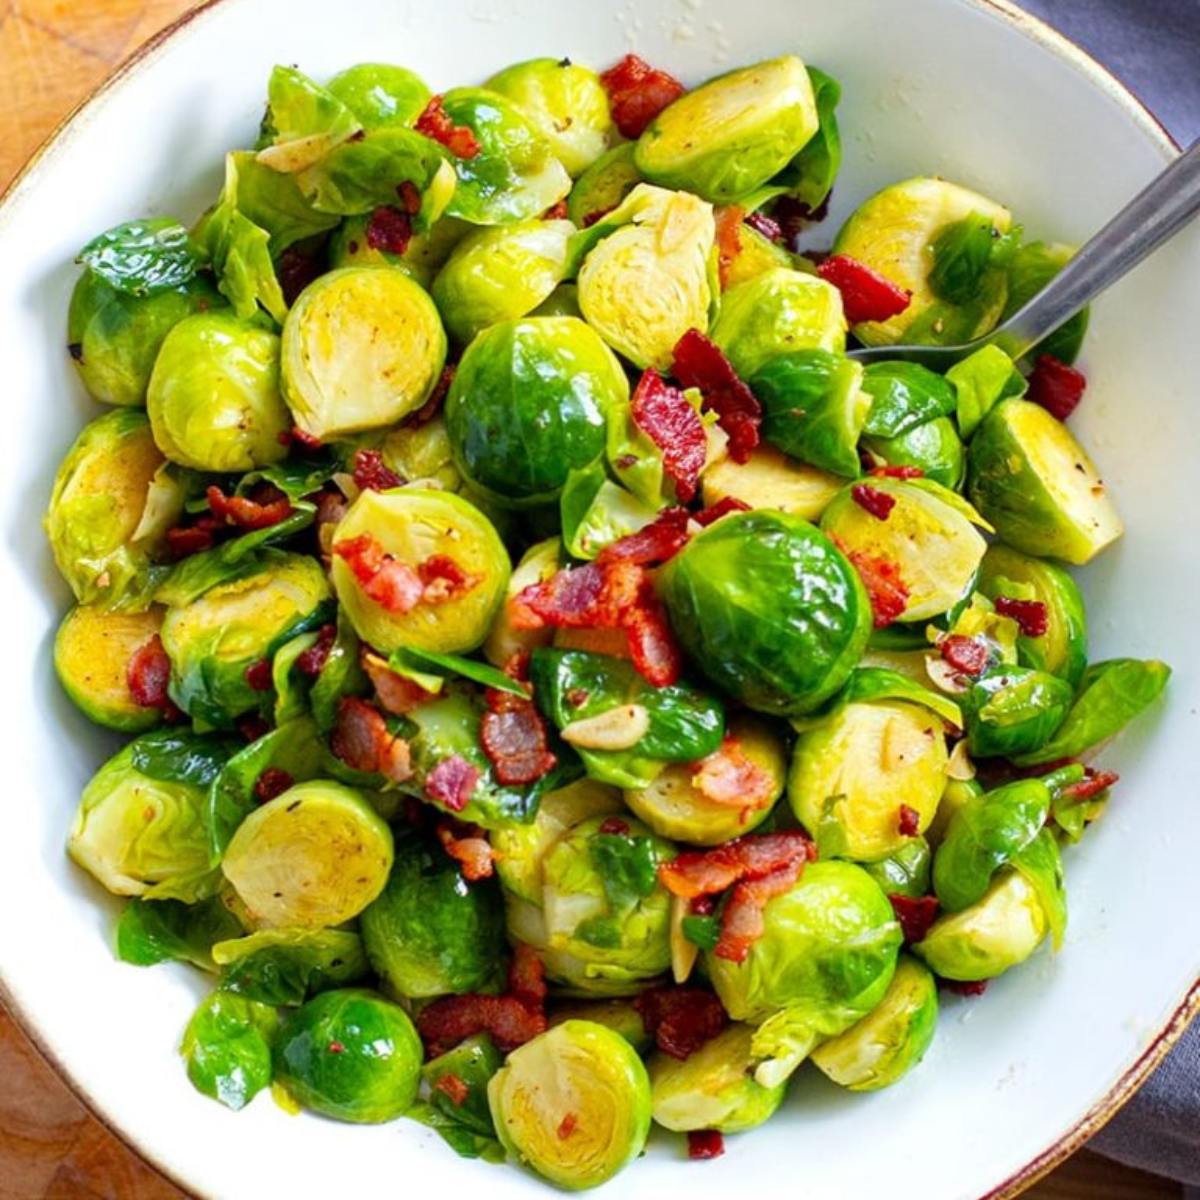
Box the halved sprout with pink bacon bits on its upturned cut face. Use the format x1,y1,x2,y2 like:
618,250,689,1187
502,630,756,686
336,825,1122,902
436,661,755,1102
332,487,509,654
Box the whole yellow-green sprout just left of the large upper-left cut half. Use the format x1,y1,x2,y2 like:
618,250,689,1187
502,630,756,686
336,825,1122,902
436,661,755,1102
146,312,292,470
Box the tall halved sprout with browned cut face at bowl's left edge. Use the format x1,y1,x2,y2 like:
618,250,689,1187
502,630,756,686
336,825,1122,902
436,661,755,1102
44,408,163,608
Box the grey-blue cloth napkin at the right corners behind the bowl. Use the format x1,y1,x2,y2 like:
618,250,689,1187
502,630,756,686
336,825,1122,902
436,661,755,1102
1024,0,1200,1185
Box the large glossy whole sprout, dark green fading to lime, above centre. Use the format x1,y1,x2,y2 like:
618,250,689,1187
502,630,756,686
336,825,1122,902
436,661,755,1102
446,317,629,508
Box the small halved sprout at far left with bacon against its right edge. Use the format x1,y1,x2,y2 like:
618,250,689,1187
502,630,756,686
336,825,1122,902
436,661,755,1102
54,605,162,733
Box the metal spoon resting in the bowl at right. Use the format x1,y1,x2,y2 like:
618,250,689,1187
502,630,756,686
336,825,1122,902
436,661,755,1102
850,140,1200,371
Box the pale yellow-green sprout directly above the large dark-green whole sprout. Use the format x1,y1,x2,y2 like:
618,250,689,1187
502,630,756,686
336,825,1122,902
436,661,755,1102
432,221,575,346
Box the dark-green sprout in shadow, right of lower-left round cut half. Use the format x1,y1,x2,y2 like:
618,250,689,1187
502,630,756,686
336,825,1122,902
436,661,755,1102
362,834,504,1000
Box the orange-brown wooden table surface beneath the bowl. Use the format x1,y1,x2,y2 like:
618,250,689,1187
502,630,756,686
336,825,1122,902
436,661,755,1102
0,0,1181,1200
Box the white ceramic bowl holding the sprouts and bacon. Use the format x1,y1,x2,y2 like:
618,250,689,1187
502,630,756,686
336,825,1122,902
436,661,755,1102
0,0,1200,1200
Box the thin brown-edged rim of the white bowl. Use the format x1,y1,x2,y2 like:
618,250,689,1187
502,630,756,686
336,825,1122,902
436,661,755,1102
0,0,1200,1200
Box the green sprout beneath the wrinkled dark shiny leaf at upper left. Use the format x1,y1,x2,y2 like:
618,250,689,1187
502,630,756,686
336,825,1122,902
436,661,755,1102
67,271,224,404
